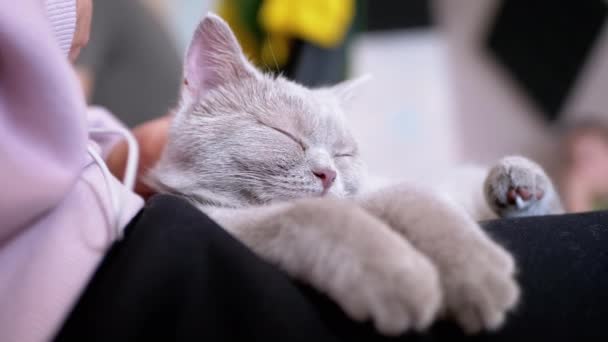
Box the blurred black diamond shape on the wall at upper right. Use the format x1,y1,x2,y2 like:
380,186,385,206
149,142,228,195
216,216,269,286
487,0,607,121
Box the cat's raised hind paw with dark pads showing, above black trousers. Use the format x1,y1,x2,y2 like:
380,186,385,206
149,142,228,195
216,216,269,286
483,156,564,217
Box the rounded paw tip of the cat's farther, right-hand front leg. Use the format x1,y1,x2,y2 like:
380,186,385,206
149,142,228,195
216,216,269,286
444,234,520,334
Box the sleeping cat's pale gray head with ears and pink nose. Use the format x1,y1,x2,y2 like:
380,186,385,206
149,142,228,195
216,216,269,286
149,14,363,206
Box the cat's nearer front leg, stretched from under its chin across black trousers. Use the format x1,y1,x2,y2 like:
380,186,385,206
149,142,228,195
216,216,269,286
201,198,442,335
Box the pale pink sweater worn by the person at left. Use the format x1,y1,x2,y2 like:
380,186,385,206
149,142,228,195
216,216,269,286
0,0,143,342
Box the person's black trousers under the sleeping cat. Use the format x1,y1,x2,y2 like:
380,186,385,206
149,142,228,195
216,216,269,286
56,196,608,341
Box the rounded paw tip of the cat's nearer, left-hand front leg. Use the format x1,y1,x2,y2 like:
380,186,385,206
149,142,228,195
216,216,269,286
334,238,442,336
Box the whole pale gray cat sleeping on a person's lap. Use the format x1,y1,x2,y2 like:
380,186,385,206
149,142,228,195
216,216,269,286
148,14,564,335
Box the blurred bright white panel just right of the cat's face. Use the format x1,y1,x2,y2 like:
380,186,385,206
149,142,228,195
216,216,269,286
350,30,460,178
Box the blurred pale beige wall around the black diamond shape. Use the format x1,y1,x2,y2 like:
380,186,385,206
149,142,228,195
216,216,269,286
435,0,608,176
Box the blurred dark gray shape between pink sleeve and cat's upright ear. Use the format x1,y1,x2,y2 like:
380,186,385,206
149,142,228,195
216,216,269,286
77,0,182,127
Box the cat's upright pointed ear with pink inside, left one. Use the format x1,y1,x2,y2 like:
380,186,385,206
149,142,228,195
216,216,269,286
184,13,259,98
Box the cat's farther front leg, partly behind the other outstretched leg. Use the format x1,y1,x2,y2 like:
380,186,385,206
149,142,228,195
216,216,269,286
359,184,519,333
